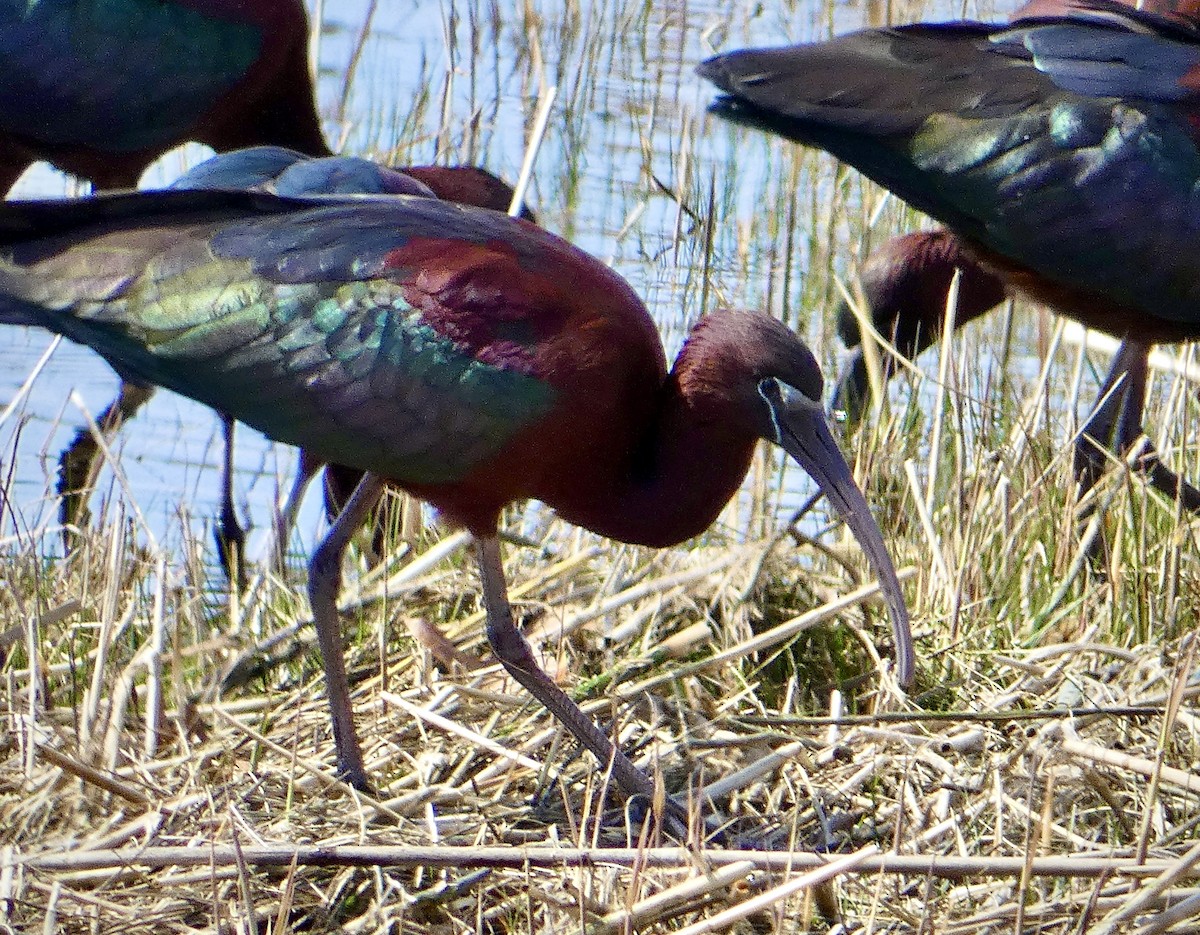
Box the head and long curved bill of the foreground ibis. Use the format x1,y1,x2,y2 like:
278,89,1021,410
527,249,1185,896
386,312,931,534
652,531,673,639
685,311,914,685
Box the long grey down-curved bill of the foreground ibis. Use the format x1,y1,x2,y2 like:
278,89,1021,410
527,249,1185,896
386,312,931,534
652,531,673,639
772,386,916,687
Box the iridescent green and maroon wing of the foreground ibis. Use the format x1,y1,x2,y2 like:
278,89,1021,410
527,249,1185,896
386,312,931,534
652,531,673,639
0,192,560,483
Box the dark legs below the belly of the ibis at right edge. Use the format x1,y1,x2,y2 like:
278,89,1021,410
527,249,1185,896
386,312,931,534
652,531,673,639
1075,340,1200,513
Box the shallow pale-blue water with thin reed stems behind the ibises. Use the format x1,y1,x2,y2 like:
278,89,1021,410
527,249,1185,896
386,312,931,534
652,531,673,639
0,0,1056,571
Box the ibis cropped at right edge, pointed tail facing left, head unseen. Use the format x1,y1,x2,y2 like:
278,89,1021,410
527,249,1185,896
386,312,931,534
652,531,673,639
701,0,1200,507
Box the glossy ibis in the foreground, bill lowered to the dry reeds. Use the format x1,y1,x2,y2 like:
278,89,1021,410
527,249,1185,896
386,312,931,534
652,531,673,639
0,191,913,793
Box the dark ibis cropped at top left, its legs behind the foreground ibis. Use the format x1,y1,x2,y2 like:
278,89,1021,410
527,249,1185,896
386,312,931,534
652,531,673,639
0,0,329,571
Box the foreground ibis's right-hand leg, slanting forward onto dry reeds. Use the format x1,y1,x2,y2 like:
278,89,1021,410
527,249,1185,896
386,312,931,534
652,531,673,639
475,535,691,810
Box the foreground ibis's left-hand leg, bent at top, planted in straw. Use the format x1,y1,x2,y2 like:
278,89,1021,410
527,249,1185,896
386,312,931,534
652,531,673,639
308,474,383,790
